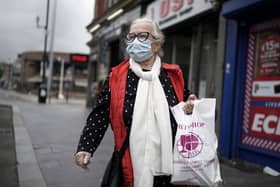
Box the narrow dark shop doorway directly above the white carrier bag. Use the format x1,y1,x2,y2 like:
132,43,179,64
190,21,220,98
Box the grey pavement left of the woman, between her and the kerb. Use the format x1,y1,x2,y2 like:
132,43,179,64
0,90,113,187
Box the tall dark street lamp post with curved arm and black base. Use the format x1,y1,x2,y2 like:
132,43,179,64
36,0,50,103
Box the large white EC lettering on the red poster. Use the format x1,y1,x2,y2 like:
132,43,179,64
252,113,280,135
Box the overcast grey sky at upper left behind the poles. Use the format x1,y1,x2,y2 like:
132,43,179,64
0,0,94,61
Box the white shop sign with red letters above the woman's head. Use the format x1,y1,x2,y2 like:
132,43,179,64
146,0,212,29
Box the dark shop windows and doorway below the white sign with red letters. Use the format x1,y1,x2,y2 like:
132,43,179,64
163,16,222,98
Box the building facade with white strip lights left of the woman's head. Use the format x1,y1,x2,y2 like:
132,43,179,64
87,0,150,106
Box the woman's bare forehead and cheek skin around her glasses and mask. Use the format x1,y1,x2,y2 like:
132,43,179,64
129,21,160,54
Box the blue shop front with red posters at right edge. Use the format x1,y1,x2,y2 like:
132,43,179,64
220,0,280,171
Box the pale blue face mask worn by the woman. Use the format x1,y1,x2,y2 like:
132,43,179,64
126,38,153,63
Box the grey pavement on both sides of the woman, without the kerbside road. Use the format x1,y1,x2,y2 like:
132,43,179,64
0,90,280,187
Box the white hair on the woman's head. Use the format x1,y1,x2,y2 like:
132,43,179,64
130,17,164,45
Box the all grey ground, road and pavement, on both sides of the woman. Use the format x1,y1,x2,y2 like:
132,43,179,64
0,89,280,187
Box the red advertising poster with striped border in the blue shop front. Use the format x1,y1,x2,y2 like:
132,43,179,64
241,19,280,158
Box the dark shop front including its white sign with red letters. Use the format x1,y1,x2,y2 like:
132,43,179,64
147,0,221,98
